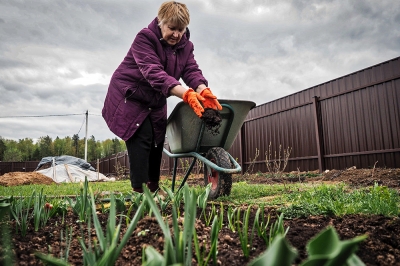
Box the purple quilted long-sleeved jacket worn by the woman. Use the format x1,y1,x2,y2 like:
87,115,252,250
102,18,208,143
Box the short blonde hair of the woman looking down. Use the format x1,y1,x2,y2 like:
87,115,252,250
157,1,190,28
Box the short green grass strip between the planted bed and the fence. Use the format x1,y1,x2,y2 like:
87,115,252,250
0,176,400,218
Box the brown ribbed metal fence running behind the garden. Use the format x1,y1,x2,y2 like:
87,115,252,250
0,57,400,175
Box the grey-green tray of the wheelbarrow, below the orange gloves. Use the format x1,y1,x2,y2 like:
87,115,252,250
167,99,256,153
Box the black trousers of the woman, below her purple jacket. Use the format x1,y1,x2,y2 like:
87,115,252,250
125,117,164,188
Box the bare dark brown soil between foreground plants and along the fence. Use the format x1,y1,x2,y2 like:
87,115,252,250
0,169,400,266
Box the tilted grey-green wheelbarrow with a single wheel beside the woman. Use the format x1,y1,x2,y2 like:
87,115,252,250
164,100,256,199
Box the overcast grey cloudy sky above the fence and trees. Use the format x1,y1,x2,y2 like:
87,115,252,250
0,0,400,140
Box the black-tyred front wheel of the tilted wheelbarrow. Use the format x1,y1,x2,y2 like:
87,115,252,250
204,147,232,199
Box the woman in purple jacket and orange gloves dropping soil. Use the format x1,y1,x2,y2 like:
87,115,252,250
102,1,222,193
